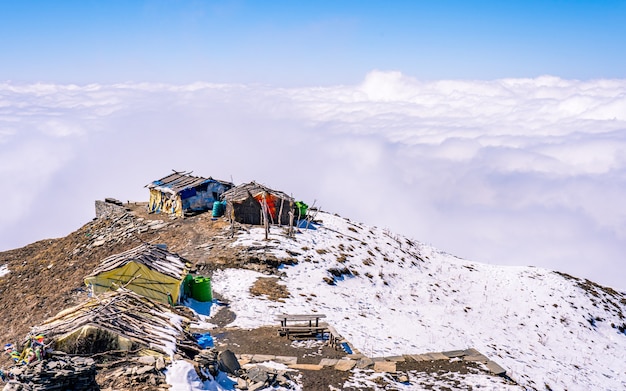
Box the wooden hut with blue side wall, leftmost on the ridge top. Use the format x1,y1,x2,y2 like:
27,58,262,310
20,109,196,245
146,171,233,216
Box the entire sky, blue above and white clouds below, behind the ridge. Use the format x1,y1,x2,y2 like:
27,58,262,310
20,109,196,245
0,0,626,289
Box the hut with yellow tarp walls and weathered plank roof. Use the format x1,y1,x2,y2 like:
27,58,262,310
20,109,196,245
85,243,189,304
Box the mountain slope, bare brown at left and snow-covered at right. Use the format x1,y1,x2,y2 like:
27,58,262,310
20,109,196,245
0,204,626,390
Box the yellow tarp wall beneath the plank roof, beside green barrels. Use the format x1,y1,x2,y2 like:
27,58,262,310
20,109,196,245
85,262,183,304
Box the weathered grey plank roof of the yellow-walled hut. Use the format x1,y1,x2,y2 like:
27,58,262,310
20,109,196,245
86,243,189,280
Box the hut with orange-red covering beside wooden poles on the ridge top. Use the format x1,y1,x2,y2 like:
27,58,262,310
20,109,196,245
222,182,294,225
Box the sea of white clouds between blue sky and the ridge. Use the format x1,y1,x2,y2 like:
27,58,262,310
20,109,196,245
0,71,626,289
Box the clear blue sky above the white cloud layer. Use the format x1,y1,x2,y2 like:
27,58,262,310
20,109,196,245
0,1,626,86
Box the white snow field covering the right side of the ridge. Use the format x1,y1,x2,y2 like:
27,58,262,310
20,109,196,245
208,213,626,391
